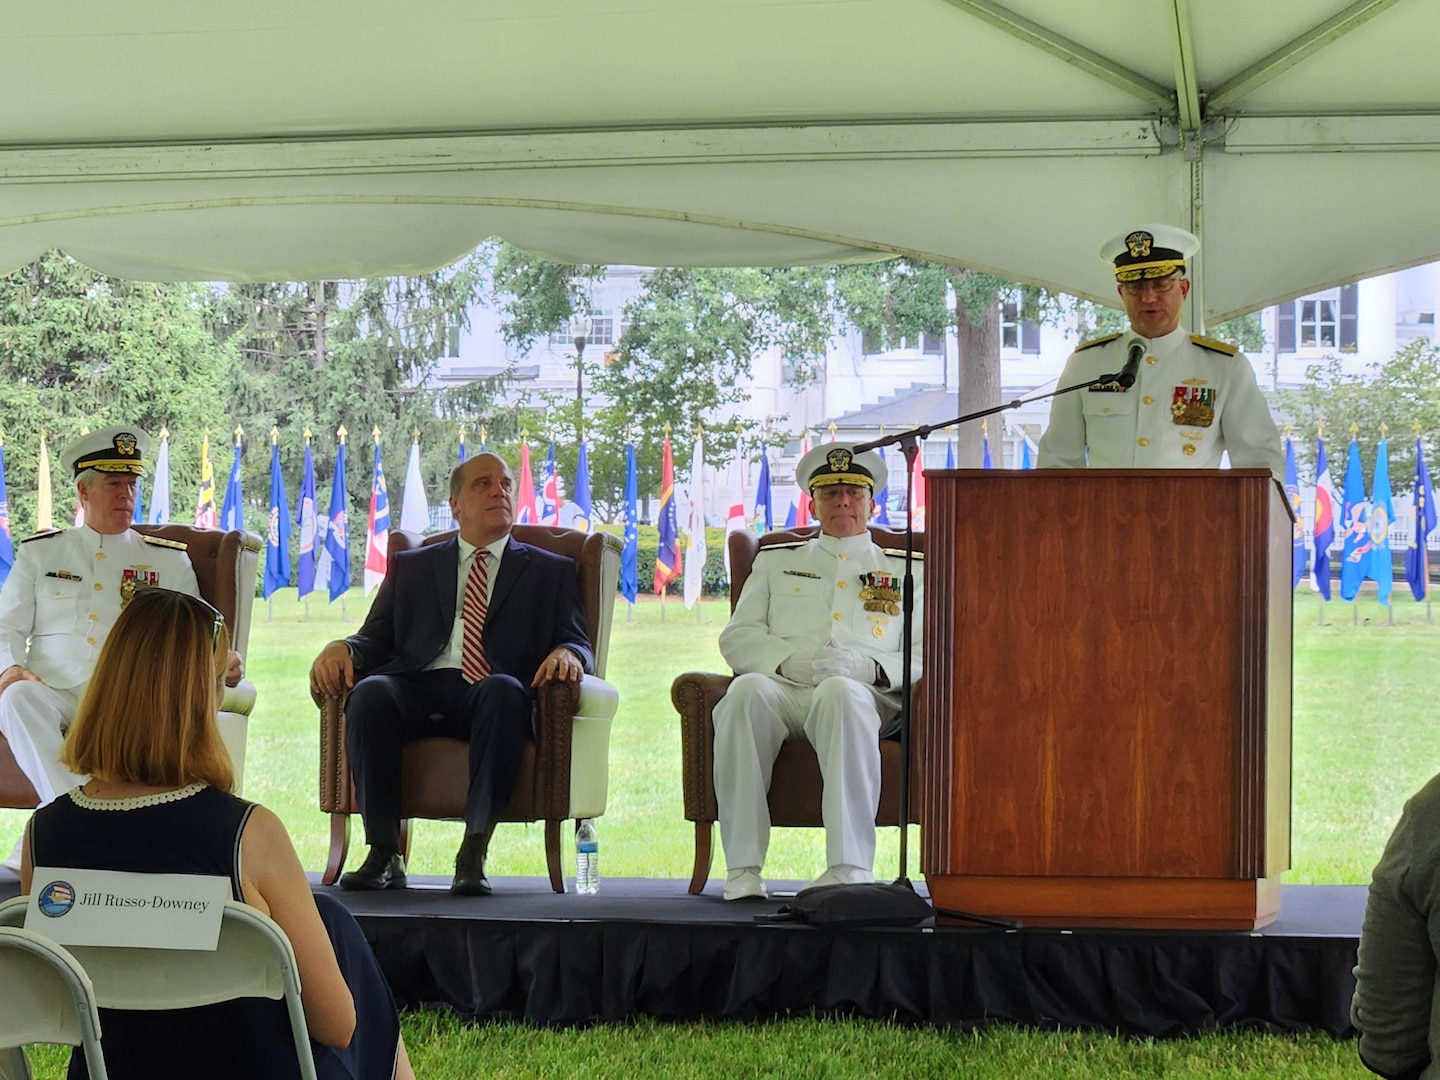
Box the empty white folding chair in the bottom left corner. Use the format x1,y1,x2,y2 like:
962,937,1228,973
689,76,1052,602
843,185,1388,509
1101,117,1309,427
0,926,105,1080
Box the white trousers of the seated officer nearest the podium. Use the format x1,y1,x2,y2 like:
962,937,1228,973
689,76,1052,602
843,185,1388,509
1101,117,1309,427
713,672,896,870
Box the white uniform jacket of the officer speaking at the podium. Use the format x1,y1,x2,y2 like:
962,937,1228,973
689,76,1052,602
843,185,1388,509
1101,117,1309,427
1038,327,1284,480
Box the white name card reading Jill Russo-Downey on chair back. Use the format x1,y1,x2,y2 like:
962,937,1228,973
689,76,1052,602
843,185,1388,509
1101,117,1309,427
24,867,230,952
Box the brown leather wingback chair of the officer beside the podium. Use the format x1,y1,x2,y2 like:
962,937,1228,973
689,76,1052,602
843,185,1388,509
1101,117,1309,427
670,526,924,893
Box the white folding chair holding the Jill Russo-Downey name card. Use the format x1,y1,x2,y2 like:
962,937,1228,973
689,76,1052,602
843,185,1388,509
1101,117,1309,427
0,896,315,1080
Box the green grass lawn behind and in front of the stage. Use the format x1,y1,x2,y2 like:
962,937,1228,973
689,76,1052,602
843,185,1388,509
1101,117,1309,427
8,589,1440,1077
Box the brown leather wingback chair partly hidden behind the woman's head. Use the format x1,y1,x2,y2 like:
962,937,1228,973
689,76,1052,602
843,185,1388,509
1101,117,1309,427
0,524,262,809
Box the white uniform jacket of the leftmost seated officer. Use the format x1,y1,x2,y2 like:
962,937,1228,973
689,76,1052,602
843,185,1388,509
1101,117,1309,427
0,526,200,690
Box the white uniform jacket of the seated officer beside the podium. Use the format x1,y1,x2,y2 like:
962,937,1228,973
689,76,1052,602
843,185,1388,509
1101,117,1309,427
720,533,923,706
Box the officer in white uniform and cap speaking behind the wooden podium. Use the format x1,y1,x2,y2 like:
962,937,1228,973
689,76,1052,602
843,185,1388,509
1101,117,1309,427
1038,225,1284,478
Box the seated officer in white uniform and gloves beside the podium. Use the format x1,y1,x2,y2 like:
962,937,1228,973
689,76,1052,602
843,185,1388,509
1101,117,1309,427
714,442,922,900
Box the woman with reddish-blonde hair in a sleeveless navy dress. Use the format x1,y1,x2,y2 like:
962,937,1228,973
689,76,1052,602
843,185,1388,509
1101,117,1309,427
20,589,415,1080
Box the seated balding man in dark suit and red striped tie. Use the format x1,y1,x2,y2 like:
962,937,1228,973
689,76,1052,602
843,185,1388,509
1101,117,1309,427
310,454,593,896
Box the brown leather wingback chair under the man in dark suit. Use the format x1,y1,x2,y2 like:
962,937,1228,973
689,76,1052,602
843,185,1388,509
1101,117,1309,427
315,526,622,893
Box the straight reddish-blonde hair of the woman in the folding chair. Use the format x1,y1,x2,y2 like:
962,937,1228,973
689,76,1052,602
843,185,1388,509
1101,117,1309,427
60,589,235,791
